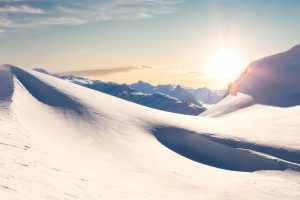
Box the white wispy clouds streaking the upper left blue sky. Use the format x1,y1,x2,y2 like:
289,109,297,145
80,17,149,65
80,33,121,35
0,0,184,32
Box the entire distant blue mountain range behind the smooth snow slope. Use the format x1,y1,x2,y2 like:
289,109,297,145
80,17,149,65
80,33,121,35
34,68,226,115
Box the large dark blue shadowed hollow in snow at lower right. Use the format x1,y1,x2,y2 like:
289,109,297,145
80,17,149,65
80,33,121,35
153,127,300,172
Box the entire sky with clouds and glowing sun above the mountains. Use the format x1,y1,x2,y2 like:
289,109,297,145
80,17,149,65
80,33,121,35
0,0,300,89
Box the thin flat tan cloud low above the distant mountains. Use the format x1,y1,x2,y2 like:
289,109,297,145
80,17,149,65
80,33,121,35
61,65,152,76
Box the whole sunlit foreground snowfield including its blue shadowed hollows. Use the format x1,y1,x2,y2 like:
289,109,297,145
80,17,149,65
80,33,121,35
0,65,300,200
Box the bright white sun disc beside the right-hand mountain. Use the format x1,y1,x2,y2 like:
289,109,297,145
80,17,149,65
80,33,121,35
207,47,245,82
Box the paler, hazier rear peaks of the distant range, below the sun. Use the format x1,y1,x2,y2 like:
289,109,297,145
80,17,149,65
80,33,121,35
130,81,227,105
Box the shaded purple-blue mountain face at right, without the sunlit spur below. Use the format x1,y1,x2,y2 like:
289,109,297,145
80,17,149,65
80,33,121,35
229,45,300,107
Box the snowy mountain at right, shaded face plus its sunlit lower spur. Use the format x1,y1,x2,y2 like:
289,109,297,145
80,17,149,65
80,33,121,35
202,45,300,116
